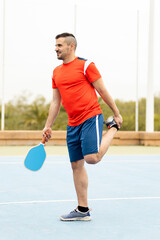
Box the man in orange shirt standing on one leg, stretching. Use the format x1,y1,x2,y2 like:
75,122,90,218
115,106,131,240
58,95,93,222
43,33,122,221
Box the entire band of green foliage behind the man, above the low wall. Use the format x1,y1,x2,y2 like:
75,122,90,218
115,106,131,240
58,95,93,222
0,96,160,131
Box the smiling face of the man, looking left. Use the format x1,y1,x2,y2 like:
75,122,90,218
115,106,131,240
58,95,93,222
55,38,71,60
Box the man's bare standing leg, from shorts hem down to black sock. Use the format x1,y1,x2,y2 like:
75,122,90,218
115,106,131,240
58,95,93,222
71,160,88,207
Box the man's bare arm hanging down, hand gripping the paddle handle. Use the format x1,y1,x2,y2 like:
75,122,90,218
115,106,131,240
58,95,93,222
43,88,61,141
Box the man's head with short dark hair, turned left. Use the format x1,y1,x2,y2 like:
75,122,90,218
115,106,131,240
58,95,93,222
55,33,77,60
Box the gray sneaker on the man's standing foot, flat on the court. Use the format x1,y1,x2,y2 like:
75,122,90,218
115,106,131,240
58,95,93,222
60,209,91,221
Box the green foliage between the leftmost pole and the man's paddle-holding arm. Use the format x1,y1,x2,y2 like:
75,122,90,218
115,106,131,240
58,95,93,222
5,96,49,130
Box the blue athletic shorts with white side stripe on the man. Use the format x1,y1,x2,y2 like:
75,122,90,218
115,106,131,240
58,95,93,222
67,114,103,162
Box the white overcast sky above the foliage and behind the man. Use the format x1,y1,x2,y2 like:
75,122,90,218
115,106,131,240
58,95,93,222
0,0,160,102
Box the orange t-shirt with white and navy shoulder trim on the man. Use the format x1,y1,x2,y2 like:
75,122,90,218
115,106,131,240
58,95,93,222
52,57,102,126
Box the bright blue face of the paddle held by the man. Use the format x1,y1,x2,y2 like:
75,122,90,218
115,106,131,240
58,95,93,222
24,143,46,171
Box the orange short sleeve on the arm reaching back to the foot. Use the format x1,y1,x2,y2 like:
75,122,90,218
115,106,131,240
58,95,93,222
85,62,101,83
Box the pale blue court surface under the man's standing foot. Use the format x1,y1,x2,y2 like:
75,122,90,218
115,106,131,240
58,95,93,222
0,152,160,240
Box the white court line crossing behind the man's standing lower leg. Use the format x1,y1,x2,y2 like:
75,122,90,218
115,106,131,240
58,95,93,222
0,197,160,205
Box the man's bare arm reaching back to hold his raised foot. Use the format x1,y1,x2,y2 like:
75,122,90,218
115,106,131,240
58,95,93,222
92,78,123,128
